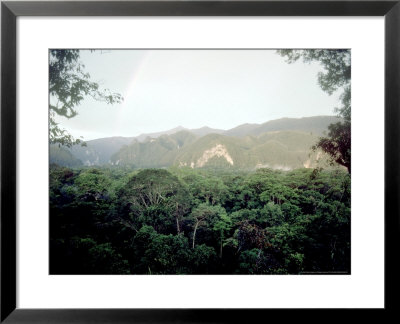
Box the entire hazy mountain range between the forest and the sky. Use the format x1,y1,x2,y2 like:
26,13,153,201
50,116,339,170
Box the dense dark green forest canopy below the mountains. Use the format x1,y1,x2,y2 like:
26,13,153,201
50,165,350,274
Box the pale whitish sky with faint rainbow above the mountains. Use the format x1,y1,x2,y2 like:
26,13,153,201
53,50,339,140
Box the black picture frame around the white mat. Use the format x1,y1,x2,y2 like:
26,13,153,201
0,0,400,323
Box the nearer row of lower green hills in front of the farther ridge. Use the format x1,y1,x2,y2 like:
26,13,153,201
111,131,326,170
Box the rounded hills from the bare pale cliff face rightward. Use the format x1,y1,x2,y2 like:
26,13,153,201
175,131,322,170
